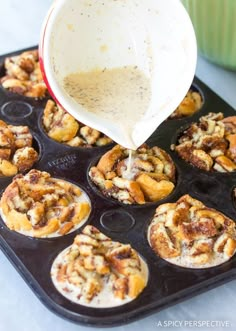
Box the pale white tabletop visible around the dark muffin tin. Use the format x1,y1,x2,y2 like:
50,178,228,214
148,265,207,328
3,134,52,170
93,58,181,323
0,0,236,331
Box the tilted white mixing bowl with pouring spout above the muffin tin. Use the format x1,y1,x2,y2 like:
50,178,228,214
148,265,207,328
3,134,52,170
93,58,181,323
40,0,197,149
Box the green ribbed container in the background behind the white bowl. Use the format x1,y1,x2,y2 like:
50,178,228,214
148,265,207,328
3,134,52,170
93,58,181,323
182,0,236,70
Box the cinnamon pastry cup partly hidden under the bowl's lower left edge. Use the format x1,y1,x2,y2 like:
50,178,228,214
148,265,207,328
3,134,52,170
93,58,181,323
43,100,112,147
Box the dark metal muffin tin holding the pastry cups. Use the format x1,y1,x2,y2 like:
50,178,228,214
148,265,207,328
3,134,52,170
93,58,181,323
0,50,236,327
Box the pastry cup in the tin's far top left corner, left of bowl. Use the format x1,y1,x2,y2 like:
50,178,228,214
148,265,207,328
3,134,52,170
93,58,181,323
1,50,47,98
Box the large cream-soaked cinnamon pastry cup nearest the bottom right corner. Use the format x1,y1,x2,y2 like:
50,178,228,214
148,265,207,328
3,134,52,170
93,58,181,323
148,195,236,268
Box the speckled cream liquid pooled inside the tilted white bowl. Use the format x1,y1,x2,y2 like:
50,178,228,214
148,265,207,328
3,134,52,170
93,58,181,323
64,66,151,146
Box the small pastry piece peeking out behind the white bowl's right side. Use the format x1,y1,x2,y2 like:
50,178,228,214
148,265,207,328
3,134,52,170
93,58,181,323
169,89,203,119
